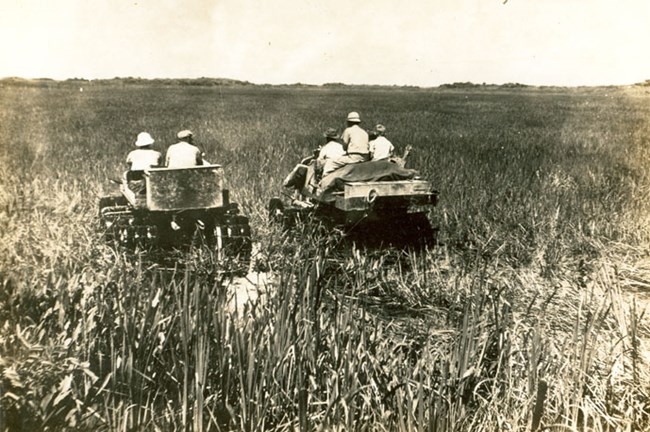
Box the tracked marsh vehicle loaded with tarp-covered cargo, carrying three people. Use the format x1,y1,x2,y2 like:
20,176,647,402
268,150,438,247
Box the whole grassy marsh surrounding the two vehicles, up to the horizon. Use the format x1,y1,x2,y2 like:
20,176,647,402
0,84,650,431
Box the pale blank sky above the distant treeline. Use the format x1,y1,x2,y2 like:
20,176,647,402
0,0,650,87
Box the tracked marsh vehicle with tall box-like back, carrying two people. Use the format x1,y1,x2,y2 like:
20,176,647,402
99,165,252,271
